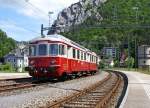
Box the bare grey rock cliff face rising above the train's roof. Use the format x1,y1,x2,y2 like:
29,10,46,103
48,0,106,34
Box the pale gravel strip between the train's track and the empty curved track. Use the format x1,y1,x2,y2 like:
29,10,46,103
0,72,108,108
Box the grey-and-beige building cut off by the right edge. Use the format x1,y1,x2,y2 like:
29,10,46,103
138,45,150,68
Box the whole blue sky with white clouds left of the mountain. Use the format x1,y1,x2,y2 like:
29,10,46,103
0,0,79,41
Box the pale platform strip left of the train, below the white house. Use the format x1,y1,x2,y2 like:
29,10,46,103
0,73,30,80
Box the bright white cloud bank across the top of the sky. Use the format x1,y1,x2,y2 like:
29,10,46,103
0,0,79,21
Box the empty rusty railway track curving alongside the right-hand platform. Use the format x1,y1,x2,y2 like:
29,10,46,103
46,72,124,108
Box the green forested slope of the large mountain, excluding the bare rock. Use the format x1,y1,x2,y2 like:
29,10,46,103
62,0,150,67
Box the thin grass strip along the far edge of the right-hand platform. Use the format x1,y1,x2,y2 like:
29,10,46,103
112,68,150,75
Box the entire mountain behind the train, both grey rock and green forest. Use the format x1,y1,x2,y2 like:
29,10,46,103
49,0,150,64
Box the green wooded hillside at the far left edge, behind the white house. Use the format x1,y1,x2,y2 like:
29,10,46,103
0,29,16,58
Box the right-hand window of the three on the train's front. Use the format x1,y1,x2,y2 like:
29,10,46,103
49,44,58,56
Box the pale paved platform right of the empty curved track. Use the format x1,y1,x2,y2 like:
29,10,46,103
121,71,150,108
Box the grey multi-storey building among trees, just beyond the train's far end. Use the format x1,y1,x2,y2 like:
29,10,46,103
103,47,117,58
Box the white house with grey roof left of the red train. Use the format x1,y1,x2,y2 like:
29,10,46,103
4,43,29,72
